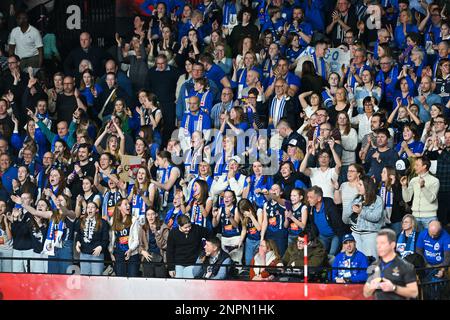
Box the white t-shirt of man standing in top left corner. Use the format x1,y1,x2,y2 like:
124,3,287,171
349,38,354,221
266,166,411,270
9,25,44,59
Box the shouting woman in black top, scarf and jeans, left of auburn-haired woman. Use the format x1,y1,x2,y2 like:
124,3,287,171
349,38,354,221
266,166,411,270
75,202,109,275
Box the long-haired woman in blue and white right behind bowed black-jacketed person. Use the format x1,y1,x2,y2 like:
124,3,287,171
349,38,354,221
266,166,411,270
185,180,217,231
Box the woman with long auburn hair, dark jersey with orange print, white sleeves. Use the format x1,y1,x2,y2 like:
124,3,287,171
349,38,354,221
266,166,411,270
108,199,140,277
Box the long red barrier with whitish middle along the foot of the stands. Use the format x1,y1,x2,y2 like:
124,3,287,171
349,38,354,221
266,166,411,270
0,273,370,300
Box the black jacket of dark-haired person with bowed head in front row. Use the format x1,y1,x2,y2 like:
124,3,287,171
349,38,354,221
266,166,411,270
167,224,209,271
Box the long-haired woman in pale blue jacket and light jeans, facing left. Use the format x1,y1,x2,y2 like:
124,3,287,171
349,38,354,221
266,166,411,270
350,176,385,258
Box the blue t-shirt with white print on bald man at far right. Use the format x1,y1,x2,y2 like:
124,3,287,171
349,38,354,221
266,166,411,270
416,229,450,265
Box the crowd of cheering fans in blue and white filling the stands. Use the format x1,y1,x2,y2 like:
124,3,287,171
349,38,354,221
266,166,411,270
0,0,450,290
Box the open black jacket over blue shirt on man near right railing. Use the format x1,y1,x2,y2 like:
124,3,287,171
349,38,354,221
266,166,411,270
306,198,349,237
